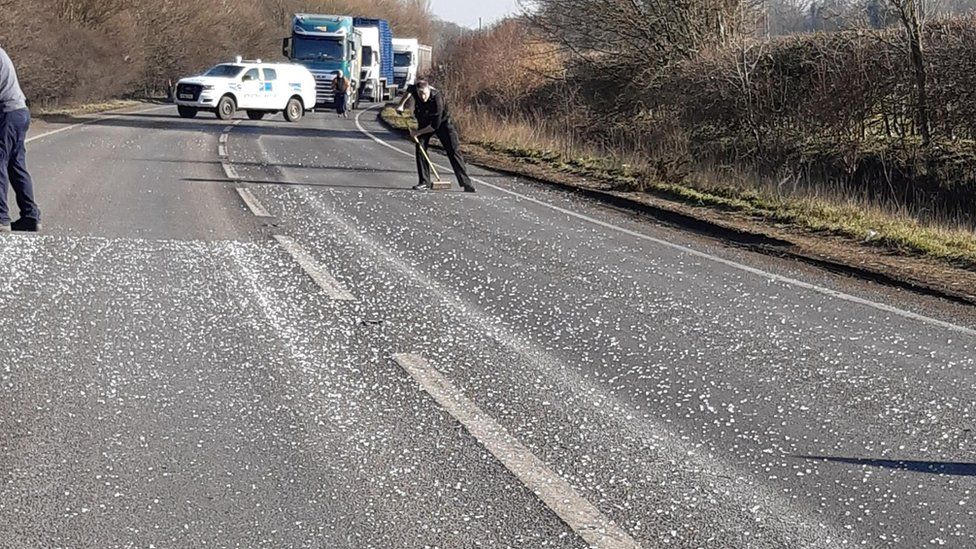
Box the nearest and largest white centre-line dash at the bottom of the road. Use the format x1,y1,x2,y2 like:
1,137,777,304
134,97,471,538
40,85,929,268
393,354,640,549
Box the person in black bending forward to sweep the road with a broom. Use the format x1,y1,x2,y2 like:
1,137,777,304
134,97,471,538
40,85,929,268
396,80,475,193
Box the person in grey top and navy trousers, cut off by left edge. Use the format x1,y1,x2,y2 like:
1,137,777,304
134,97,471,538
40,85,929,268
0,48,41,232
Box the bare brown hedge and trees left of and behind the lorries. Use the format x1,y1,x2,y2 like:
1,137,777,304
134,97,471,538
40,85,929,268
0,0,433,105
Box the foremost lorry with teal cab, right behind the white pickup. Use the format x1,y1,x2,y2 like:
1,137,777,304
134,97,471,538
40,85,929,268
281,13,363,108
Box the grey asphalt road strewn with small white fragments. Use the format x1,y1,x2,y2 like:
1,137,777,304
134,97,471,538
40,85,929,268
0,107,976,548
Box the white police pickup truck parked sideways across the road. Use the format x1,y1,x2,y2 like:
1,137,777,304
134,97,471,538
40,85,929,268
174,57,315,122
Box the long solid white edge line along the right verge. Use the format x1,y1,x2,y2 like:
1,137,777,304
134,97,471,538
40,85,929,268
356,107,976,337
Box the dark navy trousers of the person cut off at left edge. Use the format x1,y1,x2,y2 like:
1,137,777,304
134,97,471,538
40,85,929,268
0,109,41,225
